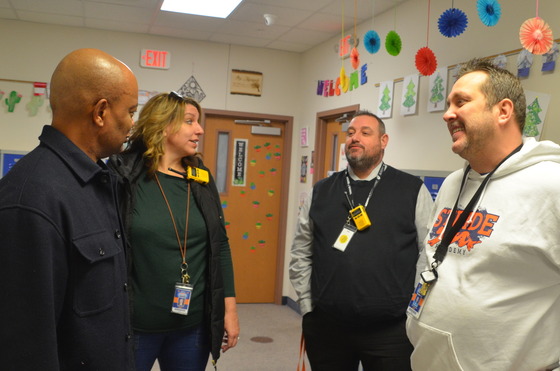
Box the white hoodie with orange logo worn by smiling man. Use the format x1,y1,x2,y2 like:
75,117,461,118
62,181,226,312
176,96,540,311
407,138,560,371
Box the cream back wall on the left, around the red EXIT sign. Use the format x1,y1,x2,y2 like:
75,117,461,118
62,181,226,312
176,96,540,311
0,20,301,150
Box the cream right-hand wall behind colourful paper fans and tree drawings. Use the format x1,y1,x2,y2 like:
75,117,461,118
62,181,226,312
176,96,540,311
284,0,560,298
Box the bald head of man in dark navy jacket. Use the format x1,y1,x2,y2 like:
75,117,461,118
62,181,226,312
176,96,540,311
50,49,138,160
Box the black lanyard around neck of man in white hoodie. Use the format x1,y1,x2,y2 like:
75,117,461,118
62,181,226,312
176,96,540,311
432,144,523,268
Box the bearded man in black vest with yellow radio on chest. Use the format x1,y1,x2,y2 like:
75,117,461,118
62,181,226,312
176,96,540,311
290,111,432,371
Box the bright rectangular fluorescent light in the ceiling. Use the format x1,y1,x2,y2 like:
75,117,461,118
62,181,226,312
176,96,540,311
161,0,243,18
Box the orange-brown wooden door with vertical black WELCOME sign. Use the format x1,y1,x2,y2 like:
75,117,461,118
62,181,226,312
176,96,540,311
203,115,287,303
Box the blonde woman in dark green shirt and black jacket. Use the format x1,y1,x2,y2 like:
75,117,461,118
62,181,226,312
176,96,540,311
109,92,239,371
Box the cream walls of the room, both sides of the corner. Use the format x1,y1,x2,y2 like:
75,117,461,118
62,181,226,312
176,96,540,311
0,0,560,299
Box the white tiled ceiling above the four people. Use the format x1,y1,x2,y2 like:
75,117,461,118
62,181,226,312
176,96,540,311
0,0,407,52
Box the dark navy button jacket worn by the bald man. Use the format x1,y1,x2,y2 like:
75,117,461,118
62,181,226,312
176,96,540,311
0,126,133,371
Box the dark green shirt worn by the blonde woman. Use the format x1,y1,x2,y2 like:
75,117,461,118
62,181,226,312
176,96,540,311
130,173,234,332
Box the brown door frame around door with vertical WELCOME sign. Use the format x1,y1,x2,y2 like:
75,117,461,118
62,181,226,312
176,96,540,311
200,109,294,305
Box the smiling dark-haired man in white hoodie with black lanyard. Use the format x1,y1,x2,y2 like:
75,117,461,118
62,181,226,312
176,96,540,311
407,59,560,371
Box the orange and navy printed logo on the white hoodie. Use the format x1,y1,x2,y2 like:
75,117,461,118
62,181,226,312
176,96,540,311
428,208,500,255
